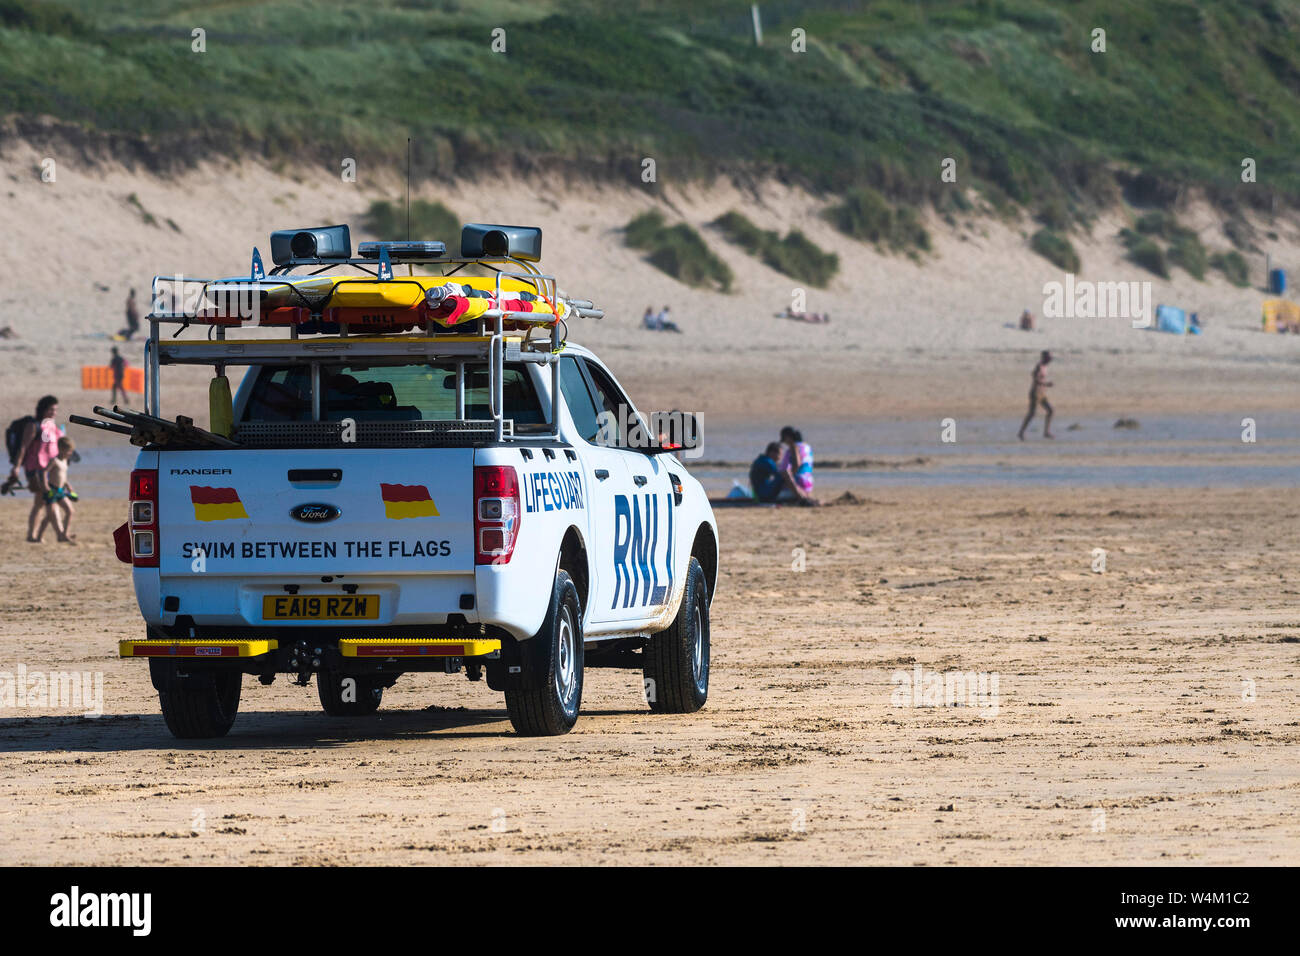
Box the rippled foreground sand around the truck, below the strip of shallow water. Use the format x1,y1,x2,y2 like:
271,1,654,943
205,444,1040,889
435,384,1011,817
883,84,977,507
0,488,1300,865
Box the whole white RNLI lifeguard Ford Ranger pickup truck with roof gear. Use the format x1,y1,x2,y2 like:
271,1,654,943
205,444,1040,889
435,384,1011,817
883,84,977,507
89,226,719,737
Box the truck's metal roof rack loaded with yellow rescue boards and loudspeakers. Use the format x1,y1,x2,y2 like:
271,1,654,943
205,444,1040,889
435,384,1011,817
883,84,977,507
129,224,605,447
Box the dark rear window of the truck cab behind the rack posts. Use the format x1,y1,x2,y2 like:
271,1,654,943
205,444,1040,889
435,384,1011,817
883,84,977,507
241,363,546,425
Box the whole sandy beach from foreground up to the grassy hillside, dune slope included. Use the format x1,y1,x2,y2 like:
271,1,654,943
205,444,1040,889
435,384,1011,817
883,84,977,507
0,155,1300,865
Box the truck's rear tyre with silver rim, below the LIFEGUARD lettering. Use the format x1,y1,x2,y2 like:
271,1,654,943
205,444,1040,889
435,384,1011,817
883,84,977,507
506,570,582,737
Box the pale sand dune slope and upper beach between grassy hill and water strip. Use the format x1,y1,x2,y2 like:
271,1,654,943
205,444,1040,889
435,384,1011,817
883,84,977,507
0,142,1300,431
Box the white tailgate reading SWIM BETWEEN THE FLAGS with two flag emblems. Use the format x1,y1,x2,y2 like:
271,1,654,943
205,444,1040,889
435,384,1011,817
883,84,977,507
159,447,475,578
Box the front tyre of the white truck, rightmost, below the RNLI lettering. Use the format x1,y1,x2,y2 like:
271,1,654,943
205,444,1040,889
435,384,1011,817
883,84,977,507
642,558,709,714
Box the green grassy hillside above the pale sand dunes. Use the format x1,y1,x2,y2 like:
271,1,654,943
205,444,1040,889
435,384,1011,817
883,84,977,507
0,0,1300,224
